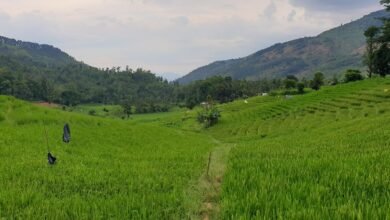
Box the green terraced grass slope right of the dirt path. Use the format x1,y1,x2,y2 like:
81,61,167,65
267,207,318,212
212,80,390,219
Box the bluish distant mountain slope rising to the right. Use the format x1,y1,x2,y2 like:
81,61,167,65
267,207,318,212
178,10,389,84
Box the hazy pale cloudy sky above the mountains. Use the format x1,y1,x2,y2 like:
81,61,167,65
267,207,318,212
0,0,382,74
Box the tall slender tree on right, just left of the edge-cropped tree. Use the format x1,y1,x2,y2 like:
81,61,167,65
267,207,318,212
364,26,380,78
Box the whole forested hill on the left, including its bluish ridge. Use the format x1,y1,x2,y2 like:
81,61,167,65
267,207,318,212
0,37,173,109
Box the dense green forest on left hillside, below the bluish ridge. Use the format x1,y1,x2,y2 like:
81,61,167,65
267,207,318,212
0,63,173,110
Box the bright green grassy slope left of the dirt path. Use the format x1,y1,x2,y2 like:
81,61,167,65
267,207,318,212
0,96,213,219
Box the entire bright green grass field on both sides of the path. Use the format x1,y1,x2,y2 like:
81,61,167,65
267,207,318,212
0,79,390,219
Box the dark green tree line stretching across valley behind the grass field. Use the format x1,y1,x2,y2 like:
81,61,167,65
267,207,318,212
0,59,378,116
